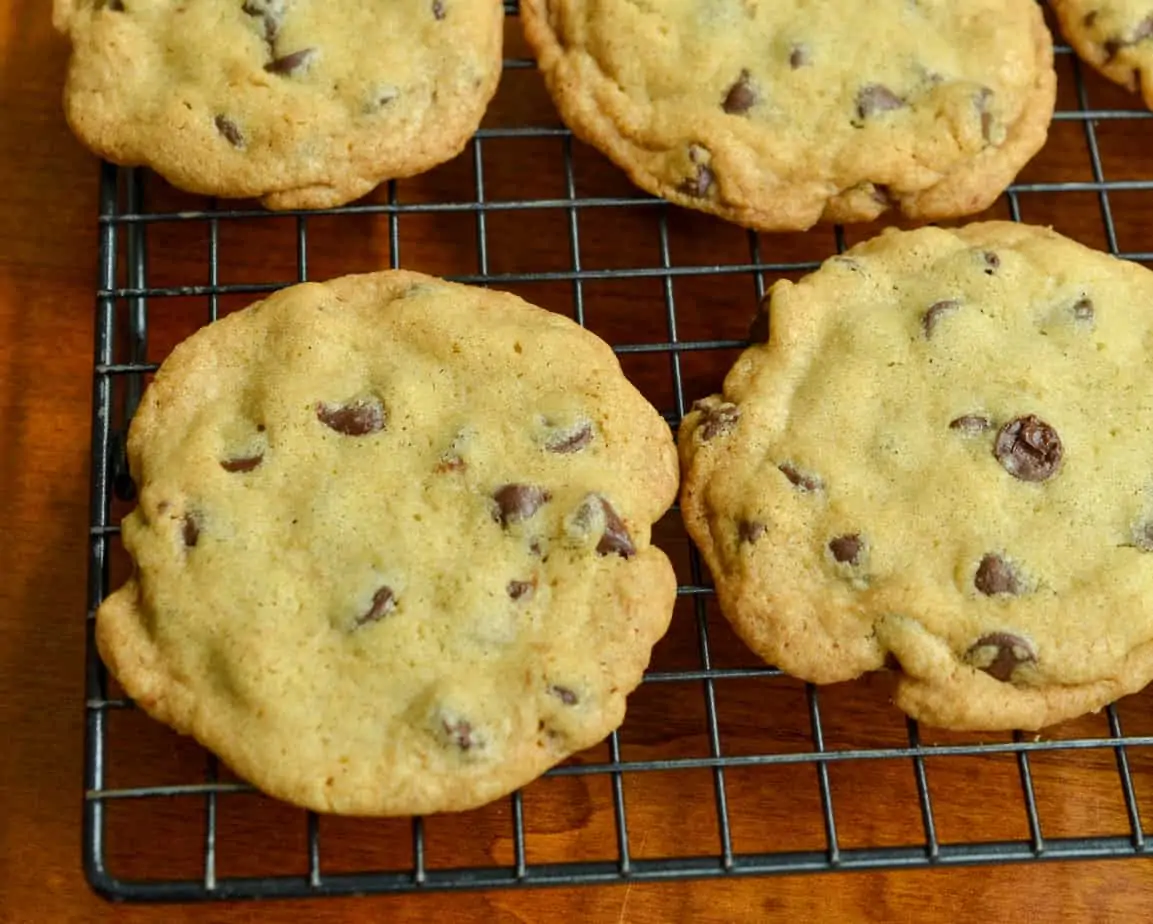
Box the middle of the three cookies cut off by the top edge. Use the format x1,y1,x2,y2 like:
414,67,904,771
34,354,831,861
521,0,1056,231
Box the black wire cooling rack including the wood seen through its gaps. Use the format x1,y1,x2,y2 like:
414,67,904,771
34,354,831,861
83,0,1153,901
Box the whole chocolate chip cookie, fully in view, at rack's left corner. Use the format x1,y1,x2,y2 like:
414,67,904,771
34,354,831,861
96,272,677,814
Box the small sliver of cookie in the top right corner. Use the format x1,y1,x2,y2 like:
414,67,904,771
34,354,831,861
1049,0,1153,108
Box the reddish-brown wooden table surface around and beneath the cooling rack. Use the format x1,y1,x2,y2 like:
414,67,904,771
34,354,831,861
0,0,1153,924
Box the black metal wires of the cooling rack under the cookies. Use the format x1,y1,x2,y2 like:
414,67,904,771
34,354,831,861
83,0,1153,901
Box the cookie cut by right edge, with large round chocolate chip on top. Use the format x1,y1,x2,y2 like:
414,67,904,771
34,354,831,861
679,223,1153,730
